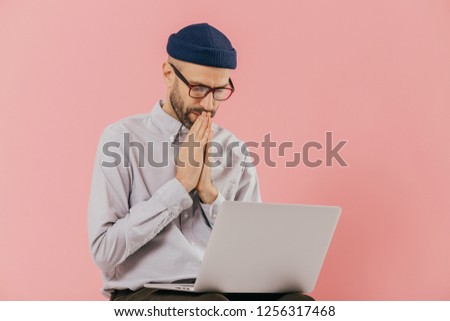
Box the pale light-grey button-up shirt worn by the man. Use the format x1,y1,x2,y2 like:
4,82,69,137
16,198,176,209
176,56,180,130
88,101,261,296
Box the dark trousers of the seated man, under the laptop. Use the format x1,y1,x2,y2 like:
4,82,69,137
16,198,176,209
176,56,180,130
110,288,314,301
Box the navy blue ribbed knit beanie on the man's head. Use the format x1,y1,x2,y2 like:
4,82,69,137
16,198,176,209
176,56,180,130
167,23,237,69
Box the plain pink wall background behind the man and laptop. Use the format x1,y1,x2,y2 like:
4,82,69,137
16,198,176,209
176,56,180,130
0,0,450,300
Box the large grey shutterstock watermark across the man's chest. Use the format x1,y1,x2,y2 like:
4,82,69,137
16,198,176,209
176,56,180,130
102,132,349,168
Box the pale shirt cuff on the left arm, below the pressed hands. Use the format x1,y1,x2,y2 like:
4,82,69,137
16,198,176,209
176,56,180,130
155,178,193,213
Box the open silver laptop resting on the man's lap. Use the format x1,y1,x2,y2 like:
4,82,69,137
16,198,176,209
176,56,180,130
144,201,341,293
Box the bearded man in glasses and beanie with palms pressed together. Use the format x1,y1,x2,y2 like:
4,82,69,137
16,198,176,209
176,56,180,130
89,23,312,300
